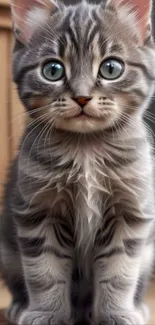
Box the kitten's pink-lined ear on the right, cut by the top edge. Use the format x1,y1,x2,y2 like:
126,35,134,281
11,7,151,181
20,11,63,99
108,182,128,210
107,0,152,40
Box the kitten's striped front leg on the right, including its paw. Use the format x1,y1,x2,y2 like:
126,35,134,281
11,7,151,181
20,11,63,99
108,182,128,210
93,218,152,325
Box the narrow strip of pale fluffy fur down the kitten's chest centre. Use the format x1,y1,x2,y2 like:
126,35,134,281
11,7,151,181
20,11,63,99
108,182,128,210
75,155,111,245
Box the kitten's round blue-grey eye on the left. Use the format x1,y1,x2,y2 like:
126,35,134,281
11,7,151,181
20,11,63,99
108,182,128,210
42,60,65,81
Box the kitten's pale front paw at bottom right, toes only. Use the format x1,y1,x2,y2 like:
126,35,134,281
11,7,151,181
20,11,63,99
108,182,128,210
98,311,145,325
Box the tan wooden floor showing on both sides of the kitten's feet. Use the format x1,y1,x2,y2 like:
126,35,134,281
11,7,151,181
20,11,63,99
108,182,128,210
0,280,155,325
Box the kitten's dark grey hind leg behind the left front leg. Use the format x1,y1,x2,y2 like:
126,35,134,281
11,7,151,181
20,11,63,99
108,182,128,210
0,214,28,319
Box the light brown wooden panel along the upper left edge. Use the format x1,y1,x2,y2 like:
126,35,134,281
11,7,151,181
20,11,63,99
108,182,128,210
0,0,24,202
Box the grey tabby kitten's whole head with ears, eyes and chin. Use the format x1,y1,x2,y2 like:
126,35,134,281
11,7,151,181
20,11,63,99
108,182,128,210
12,0,155,133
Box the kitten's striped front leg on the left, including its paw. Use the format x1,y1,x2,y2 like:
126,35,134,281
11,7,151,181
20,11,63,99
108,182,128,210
6,216,73,325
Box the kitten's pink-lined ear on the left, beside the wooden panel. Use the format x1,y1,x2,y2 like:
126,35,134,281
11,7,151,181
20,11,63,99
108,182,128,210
11,0,57,44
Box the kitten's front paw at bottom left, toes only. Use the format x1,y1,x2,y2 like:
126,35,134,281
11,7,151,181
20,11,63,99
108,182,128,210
18,311,72,325
